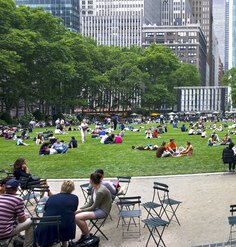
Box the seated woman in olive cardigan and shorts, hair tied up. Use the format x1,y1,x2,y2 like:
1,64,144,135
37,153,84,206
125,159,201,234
75,173,112,240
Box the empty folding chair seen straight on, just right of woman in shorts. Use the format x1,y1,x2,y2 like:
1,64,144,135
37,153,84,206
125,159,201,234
118,196,142,238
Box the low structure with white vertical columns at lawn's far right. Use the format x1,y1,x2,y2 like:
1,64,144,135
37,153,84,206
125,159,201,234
176,86,230,112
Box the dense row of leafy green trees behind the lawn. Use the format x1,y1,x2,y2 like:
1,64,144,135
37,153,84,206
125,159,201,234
0,0,200,119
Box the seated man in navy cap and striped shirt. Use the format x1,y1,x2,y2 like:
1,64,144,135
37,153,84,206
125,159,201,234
0,179,33,247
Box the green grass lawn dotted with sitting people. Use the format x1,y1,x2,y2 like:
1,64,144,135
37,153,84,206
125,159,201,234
0,123,229,178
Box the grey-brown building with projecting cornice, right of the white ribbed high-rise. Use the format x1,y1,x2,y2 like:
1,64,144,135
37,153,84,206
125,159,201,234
142,24,207,86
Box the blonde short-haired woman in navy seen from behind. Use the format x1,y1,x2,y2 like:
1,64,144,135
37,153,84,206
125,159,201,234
36,180,79,247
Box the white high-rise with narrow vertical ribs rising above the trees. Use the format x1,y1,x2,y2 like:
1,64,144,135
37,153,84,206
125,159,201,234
80,0,161,47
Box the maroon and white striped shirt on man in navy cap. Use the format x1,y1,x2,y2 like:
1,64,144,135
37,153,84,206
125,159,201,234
0,194,25,239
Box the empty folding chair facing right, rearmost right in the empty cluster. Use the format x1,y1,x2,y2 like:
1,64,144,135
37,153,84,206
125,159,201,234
154,182,182,225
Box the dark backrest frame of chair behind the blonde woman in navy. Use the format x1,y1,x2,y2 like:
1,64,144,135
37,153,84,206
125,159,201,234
31,215,62,246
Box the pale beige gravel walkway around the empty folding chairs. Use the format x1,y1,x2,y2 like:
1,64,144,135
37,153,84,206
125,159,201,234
48,173,236,247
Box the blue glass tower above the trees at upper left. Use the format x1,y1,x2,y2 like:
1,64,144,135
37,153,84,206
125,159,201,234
16,0,80,32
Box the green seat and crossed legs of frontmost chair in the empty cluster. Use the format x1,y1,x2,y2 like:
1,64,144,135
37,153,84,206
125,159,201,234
142,217,169,246
